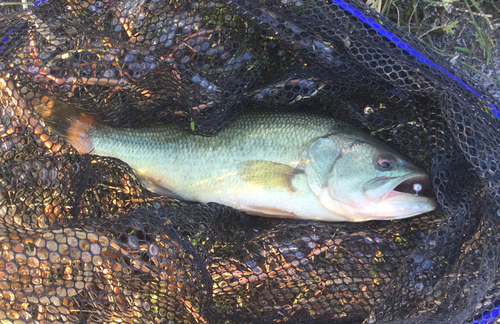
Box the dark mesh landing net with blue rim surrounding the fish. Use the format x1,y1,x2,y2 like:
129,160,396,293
0,0,500,324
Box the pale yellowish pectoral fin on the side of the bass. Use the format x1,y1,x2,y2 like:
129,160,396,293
238,161,304,192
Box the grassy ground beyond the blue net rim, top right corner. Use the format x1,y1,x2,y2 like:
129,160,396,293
362,0,500,88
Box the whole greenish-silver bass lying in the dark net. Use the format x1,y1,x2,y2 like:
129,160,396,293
45,104,437,222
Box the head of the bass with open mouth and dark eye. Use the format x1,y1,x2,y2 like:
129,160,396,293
302,136,437,222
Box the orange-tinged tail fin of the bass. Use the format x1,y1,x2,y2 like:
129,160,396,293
35,100,96,154
